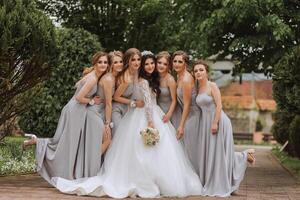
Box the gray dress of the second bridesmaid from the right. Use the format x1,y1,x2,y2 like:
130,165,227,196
177,88,201,172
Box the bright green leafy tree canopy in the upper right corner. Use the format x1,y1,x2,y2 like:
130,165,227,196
172,0,300,73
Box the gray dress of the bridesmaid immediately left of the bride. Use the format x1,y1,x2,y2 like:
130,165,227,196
111,83,135,135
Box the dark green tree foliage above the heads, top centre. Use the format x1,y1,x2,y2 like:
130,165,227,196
38,0,183,52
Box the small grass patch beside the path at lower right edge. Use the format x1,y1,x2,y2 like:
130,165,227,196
272,146,300,180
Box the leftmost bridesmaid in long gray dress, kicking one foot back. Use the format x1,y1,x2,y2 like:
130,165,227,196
24,52,108,184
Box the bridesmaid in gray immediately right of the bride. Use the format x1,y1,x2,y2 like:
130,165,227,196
156,51,180,128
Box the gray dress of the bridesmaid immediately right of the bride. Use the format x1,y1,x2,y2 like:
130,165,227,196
157,87,181,129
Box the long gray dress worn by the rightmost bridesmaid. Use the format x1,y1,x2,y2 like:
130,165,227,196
196,92,247,197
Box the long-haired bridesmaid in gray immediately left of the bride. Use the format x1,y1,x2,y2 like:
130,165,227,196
112,48,144,133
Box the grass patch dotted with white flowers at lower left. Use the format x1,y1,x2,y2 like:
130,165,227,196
0,137,36,176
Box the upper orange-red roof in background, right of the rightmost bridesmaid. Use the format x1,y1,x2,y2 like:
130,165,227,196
220,80,273,99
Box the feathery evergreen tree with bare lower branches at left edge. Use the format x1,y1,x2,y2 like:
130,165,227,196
0,0,57,136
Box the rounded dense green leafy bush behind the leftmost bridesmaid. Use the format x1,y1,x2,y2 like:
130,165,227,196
19,29,101,137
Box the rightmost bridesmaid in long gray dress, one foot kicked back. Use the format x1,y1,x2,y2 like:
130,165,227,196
193,60,254,197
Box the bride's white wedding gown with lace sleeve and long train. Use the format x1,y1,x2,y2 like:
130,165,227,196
52,79,202,198
